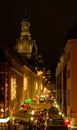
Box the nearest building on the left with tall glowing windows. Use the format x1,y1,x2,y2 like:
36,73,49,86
0,43,23,129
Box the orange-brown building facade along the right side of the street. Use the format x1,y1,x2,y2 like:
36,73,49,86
56,39,77,126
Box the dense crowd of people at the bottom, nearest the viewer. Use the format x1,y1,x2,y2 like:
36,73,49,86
14,109,47,130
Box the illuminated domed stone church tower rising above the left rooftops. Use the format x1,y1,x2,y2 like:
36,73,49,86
15,16,33,59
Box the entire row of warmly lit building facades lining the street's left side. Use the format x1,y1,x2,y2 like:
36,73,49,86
0,44,42,130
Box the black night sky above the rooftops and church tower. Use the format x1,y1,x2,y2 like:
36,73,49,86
0,0,77,80
